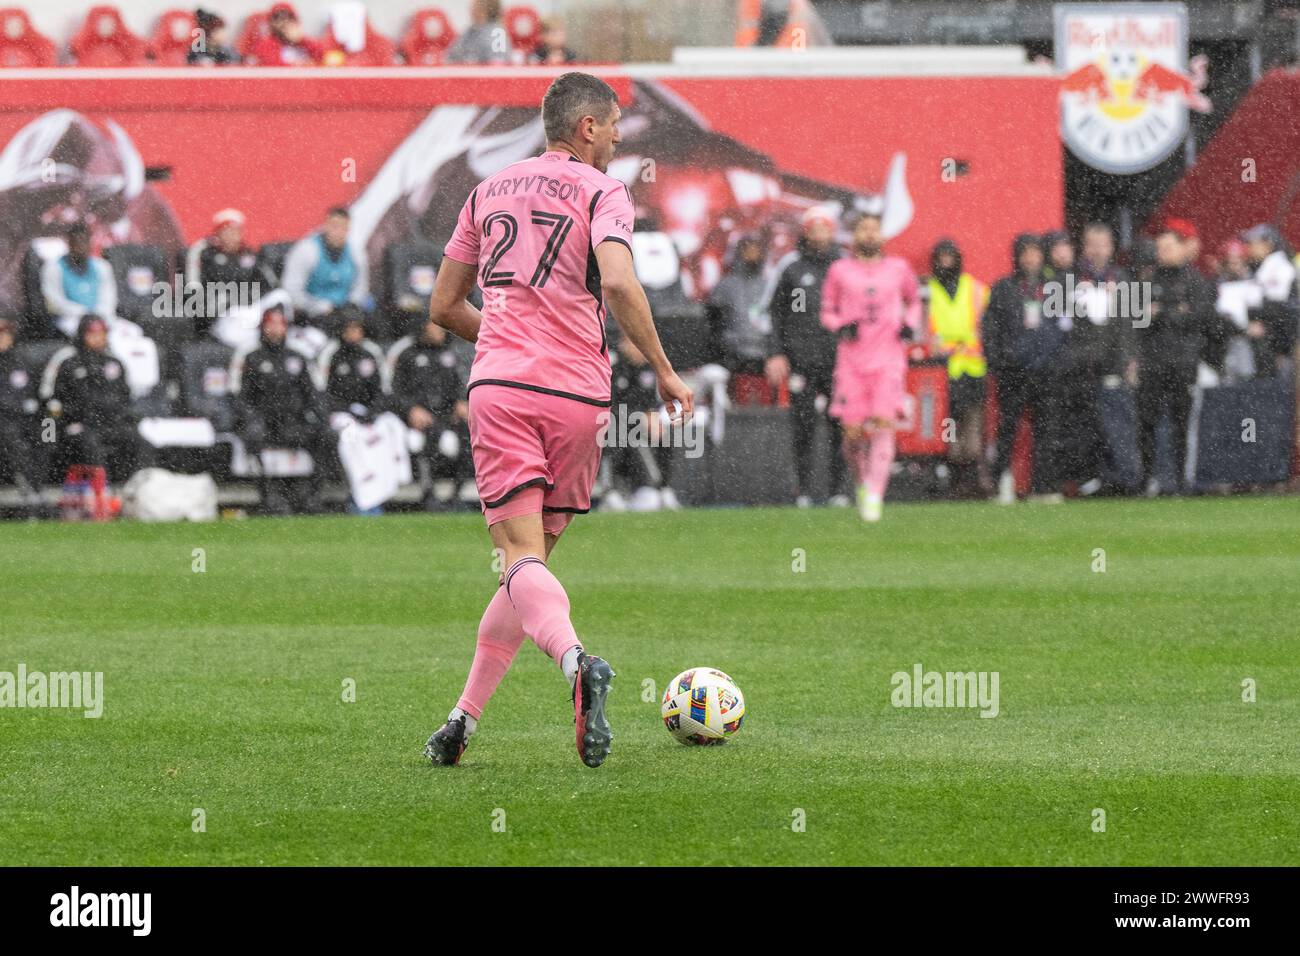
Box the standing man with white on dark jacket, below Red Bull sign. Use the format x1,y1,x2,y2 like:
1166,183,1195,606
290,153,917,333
1054,222,1141,494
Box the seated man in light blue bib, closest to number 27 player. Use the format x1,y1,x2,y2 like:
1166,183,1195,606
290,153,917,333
283,207,371,338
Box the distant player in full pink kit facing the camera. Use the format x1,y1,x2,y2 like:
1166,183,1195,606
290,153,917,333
822,213,922,522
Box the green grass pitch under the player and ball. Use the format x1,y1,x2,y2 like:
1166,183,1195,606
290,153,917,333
0,498,1300,865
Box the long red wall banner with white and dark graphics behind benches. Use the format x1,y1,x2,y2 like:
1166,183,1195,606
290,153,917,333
0,69,1062,317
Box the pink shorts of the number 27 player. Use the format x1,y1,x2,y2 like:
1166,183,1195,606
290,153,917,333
469,384,610,535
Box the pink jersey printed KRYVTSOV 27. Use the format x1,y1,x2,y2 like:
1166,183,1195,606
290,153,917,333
445,150,633,405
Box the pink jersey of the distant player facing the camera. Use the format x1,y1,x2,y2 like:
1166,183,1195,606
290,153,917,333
822,256,920,373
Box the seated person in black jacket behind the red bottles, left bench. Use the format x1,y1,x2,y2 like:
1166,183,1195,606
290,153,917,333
40,315,150,483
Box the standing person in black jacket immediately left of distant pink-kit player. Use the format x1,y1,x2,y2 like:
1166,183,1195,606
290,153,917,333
764,207,848,506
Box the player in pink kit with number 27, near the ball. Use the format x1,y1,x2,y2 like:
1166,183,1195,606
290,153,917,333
424,73,694,767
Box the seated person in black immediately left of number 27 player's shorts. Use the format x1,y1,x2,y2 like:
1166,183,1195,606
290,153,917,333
389,323,473,510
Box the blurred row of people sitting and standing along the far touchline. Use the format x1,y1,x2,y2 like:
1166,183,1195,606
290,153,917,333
0,195,1300,520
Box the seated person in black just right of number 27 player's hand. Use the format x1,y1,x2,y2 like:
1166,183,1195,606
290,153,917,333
601,336,681,511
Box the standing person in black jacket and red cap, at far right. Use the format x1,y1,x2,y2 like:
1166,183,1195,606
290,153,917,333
1136,229,1226,494
